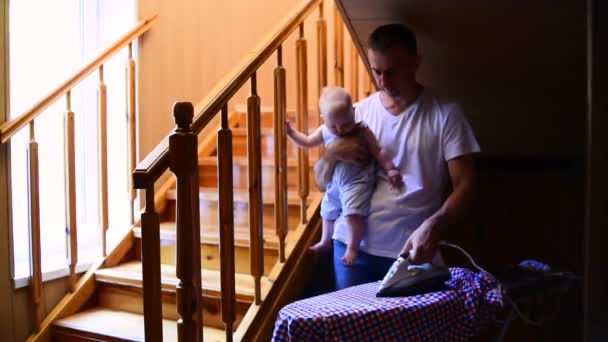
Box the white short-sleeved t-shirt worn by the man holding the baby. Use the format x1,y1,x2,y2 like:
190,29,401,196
333,89,480,258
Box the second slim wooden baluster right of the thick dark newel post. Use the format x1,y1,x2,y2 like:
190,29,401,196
247,72,264,305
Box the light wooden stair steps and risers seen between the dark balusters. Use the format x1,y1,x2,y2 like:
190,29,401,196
52,111,317,341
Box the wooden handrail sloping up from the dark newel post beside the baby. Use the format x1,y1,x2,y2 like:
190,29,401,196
133,0,323,189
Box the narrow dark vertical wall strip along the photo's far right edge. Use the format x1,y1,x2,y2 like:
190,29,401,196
583,0,608,341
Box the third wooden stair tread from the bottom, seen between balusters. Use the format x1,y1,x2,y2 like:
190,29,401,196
133,222,279,249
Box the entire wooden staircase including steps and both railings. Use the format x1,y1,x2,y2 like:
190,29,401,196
0,0,371,342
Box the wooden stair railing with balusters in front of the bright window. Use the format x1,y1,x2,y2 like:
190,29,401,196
0,16,158,332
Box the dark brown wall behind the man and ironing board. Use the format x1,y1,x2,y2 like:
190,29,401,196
339,0,586,340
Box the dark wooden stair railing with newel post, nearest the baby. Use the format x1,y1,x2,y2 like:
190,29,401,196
133,0,370,341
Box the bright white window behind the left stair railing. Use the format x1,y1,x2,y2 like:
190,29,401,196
9,0,136,279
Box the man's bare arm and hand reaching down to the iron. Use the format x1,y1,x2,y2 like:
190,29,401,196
403,154,476,264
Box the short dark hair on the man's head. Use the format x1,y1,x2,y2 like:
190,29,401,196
367,23,418,55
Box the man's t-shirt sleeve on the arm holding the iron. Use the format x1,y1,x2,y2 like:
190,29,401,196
442,105,481,160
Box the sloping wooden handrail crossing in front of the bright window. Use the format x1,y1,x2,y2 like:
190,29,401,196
0,15,158,144
